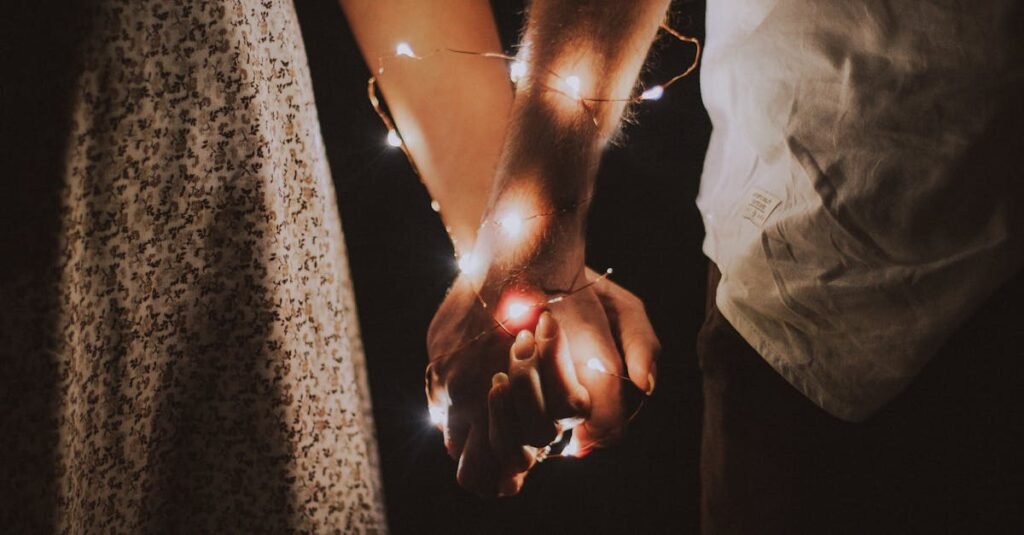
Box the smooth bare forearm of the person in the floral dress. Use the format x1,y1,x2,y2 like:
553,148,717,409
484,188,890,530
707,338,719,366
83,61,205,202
340,0,512,251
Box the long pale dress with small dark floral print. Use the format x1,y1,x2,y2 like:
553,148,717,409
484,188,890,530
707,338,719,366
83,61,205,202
0,0,386,533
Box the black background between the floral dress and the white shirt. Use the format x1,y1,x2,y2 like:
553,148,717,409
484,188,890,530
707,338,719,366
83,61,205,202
296,0,711,534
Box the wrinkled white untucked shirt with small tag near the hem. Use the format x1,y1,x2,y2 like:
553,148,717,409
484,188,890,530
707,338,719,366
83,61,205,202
697,0,1024,420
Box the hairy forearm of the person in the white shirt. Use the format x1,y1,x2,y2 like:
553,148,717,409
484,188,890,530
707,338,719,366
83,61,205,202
481,0,669,285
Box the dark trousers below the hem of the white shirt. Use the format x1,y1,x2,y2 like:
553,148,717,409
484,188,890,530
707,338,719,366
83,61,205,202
697,264,1024,534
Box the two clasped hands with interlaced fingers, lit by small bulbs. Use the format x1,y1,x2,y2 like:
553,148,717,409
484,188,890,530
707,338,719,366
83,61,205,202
427,260,659,496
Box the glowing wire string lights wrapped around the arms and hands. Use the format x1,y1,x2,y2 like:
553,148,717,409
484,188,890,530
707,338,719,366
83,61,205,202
376,23,701,461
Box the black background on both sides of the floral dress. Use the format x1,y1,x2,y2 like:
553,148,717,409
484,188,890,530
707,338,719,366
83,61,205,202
0,0,710,534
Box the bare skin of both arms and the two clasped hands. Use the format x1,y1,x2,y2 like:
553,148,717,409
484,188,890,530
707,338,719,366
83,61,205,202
342,0,669,495
